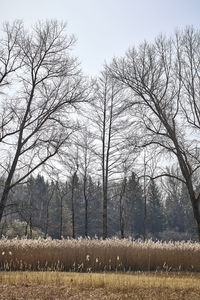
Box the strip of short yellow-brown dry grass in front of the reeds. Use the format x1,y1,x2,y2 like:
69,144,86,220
0,272,200,300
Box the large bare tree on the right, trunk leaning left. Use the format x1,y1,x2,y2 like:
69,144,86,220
111,28,200,239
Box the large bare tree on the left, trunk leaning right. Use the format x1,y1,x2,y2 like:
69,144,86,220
0,21,86,221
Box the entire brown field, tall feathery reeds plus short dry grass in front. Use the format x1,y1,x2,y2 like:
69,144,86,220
0,238,200,300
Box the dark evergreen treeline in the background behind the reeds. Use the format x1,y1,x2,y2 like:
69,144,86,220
0,173,196,240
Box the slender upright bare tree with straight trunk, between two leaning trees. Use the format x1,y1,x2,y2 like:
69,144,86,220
93,69,128,239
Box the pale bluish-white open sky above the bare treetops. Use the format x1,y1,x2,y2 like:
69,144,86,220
0,0,200,75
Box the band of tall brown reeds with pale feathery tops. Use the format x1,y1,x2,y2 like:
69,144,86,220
0,238,200,272
